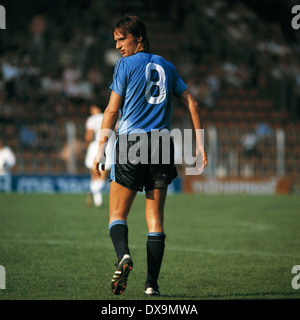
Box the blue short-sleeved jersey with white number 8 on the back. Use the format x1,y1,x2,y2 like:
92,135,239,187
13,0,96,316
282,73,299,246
110,51,187,134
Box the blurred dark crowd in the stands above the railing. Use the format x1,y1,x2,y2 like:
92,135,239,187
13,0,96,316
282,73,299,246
0,0,300,175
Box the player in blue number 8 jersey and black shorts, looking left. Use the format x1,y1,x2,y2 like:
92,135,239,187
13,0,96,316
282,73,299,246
94,16,207,295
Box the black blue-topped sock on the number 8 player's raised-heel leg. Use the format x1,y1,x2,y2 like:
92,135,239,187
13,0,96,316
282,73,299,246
109,220,130,262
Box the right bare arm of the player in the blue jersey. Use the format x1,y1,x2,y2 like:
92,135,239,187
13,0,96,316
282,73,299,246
179,90,207,173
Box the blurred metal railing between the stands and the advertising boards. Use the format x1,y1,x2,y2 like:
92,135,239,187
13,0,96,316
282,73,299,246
0,121,300,178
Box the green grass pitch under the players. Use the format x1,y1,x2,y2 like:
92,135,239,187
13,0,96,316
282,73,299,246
0,194,300,300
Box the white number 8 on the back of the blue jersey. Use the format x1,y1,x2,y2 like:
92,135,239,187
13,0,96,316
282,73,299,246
145,62,166,104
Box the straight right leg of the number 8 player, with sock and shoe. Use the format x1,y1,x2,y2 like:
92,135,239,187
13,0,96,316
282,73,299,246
145,185,168,295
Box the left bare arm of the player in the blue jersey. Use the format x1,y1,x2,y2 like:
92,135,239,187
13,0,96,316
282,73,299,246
93,91,123,176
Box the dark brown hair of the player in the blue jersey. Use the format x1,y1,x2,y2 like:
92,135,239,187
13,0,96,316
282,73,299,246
113,16,150,51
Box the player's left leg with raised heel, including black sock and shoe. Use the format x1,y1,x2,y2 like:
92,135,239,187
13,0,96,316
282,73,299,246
109,181,137,294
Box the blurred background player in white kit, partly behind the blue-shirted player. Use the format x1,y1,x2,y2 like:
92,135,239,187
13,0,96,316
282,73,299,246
85,104,112,207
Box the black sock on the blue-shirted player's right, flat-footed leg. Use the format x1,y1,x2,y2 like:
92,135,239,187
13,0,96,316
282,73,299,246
145,232,166,289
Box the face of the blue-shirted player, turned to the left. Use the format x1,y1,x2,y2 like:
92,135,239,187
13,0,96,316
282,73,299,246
114,29,141,57
